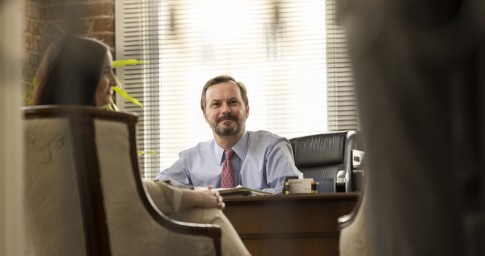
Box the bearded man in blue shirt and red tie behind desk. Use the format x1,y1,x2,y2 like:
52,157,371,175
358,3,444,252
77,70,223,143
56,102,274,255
157,75,302,193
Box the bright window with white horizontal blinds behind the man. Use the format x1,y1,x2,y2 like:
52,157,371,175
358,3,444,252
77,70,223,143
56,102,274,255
116,0,357,178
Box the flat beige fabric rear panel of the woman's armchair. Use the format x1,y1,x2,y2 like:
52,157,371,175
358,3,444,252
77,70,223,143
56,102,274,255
24,118,86,256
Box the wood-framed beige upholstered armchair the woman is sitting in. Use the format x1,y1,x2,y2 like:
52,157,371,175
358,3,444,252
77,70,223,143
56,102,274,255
23,106,221,255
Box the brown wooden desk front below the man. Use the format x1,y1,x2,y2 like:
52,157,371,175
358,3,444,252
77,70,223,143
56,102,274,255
224,193,359,256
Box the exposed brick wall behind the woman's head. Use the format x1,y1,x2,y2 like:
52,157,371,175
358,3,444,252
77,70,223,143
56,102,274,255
22,0,115,104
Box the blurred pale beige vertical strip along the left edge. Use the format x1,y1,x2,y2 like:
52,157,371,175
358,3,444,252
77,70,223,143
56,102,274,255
0,0,24,255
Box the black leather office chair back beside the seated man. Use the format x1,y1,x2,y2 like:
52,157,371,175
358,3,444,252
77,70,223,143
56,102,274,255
290,131,362,191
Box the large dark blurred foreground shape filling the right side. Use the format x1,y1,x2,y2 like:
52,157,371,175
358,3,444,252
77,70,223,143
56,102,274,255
337,0,485,256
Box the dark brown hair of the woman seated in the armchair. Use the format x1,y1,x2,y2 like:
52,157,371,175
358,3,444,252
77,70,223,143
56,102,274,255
34,36,109,106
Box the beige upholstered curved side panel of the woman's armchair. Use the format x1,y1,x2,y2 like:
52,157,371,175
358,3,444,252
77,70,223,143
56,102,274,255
95,120,214,256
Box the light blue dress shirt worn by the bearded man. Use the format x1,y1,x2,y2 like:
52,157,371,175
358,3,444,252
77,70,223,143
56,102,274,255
156,131,302,193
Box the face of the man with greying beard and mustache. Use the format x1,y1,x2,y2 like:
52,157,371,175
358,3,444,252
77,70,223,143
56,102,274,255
204,82,249,136
